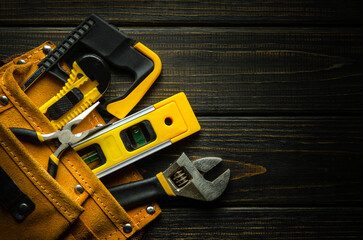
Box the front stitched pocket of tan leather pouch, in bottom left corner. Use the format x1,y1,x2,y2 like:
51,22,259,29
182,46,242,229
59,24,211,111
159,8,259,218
0,122,84,239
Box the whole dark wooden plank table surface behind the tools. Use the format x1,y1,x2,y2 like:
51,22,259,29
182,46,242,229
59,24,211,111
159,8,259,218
0,0,363,239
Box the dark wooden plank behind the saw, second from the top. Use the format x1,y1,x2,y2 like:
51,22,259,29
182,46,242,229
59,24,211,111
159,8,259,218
0,28,363,116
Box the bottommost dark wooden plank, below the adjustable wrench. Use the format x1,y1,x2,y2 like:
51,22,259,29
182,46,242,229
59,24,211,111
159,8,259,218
142,207,363,239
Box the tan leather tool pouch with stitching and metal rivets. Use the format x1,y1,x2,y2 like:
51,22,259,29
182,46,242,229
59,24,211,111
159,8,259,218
0,42,160,239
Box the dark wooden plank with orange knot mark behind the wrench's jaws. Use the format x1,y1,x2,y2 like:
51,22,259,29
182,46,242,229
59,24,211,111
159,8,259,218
135,117,363,207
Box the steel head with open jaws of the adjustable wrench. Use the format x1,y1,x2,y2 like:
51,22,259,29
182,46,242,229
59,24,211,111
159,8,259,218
163,153,230,201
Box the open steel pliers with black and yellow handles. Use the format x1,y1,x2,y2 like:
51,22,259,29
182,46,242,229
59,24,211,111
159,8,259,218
10,102,107,178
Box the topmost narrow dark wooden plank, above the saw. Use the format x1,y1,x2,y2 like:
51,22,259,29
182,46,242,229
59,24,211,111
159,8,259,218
0,0,363,26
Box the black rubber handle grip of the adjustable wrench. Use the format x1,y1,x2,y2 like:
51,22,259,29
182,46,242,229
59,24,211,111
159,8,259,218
108,176,167,209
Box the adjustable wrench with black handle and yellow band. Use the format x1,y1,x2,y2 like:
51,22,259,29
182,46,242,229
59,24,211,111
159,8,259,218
108,153,230,208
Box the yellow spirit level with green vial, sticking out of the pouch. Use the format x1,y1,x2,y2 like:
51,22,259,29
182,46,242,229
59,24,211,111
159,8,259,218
72,92,200,178
